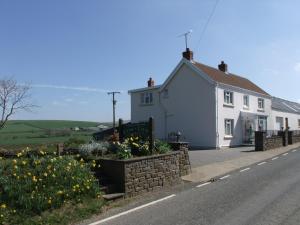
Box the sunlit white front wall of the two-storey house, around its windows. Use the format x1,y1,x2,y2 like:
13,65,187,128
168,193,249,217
216,83,272,147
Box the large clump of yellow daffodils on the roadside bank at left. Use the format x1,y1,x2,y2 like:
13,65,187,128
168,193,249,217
0,150,101,224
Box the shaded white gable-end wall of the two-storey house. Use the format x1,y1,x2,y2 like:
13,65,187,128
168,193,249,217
161,64,216,148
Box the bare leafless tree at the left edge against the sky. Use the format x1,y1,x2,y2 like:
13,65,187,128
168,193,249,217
0,78,35,130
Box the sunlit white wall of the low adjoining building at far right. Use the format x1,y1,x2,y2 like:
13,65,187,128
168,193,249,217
271,109,300,130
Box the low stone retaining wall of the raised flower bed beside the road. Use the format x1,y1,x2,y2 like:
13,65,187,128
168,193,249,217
98,144,190,197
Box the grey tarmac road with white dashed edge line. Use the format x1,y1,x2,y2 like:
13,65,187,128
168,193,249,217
90,149,300,225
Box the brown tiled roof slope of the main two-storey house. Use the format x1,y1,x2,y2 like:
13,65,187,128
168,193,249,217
192,61,270,96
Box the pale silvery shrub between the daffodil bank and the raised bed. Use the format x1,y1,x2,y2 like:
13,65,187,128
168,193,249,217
79,141,109,157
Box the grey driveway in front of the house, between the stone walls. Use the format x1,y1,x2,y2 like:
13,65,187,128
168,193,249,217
189,146,255,168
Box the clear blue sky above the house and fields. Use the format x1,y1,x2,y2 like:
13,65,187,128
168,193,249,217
0,0,300,122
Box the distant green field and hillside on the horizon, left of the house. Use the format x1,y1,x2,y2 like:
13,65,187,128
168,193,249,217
0,120,110,147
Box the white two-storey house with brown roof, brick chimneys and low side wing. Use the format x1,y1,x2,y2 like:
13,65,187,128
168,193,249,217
129,49,300,148
